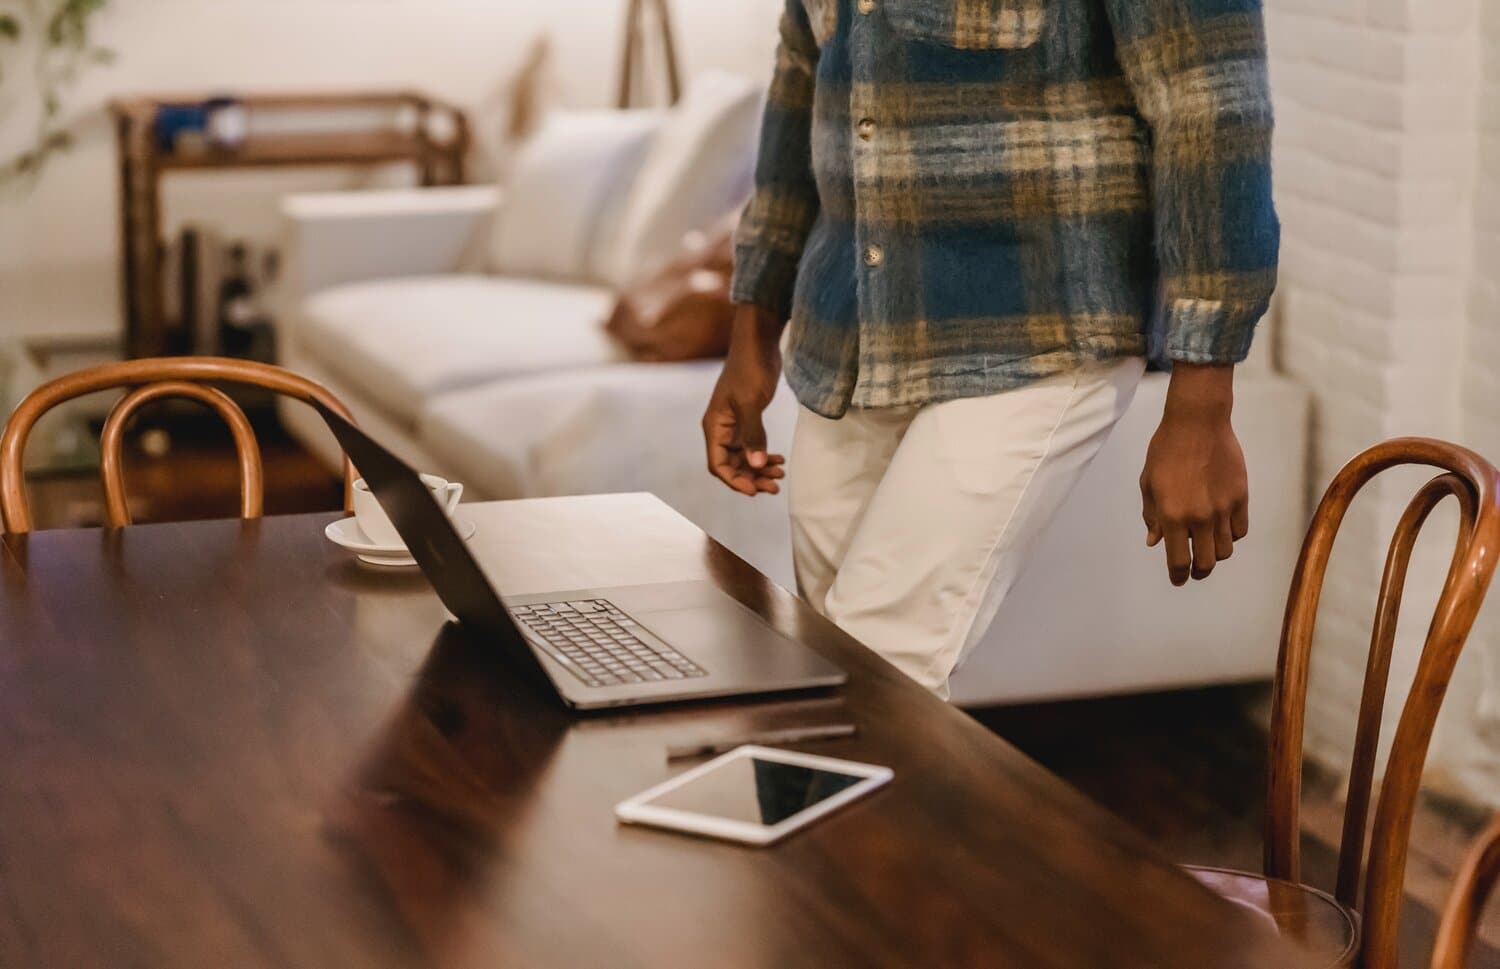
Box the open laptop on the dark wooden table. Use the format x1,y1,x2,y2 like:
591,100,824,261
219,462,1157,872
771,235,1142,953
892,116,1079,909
314,404,846,710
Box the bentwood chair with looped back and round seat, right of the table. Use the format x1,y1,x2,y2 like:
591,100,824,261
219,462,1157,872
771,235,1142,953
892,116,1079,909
1194,438,1500,969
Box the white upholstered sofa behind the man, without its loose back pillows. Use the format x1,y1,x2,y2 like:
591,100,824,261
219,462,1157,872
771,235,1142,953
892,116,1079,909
281,188,1308,705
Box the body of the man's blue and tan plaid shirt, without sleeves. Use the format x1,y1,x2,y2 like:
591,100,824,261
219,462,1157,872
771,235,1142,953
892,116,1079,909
788,0,1155,414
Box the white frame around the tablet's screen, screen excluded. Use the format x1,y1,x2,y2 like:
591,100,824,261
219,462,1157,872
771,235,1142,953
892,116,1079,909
615,746,894,846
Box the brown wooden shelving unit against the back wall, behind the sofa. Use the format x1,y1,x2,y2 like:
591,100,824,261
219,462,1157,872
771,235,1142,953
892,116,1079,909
110,92,470,357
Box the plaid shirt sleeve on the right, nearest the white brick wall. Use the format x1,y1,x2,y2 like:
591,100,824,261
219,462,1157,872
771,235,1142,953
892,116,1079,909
1107,0,1281,363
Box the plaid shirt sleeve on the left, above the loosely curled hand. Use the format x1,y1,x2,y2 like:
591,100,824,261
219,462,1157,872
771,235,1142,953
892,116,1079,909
732,0,819,321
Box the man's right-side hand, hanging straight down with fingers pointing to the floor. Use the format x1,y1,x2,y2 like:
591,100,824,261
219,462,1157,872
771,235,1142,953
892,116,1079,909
1140,363,1250,585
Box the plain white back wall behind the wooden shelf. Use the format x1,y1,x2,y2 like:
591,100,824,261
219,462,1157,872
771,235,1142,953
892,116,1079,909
0,0,777,338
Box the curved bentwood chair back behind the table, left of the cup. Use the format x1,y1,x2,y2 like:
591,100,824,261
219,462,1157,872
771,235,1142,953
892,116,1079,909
0,357,354,534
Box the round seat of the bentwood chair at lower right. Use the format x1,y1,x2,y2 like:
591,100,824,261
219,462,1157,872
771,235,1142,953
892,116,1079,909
1185,866,1359,969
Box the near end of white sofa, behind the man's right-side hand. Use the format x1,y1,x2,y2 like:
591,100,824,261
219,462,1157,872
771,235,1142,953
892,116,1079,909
953,374,1311,707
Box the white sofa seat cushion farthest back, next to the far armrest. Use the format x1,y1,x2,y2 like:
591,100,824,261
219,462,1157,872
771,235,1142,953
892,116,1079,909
300,276,627,425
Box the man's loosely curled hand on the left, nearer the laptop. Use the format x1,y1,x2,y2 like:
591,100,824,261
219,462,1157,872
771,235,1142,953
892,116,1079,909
704,306,786,498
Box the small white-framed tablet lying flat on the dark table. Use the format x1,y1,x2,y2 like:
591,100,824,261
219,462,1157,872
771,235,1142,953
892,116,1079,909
615,747,891,845
